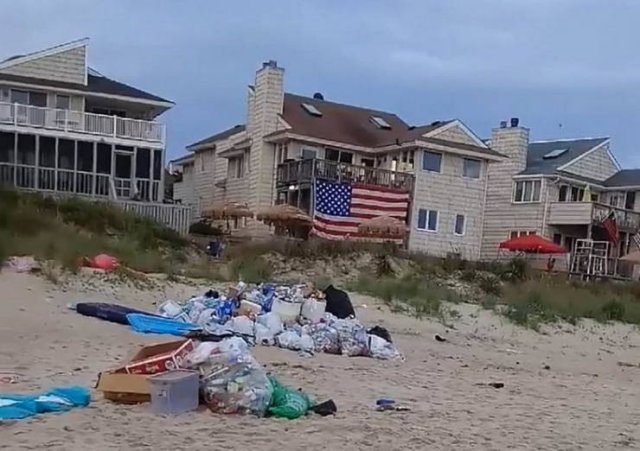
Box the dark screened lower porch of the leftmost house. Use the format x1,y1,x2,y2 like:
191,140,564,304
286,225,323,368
0,132,164,202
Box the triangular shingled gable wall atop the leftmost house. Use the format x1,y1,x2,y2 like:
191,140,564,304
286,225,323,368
0,46,86,85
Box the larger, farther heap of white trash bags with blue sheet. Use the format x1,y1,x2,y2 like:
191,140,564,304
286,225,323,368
149,282,401,359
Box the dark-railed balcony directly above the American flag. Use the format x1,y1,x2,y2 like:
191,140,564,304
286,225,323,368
276,158,413,192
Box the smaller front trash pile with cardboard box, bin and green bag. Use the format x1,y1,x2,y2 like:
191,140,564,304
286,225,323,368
95,337,324,419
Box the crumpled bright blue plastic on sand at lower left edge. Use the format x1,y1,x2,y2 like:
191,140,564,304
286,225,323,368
0,386,91,420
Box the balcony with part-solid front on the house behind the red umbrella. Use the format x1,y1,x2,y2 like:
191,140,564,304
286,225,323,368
547,202,640,232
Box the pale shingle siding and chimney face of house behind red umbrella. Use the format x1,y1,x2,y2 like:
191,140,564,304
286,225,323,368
481,128,557,260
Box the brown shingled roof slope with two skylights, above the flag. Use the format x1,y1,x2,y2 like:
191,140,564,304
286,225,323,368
282,93,409,147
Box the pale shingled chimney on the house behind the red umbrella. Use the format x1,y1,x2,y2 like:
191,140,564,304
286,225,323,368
491,117,529,175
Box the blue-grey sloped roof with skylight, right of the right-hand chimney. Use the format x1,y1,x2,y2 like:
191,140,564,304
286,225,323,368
520,138,609,175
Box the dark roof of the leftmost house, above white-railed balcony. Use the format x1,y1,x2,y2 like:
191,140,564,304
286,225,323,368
0,73,173,103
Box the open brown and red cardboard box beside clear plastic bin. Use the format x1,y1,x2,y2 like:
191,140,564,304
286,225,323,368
95,340,194,404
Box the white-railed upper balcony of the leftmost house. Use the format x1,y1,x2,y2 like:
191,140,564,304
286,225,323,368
0,102,165,144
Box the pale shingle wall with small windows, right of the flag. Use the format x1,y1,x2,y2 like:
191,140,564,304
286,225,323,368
409,152,487,260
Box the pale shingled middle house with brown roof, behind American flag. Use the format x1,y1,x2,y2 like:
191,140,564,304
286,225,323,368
172,61,502,259
